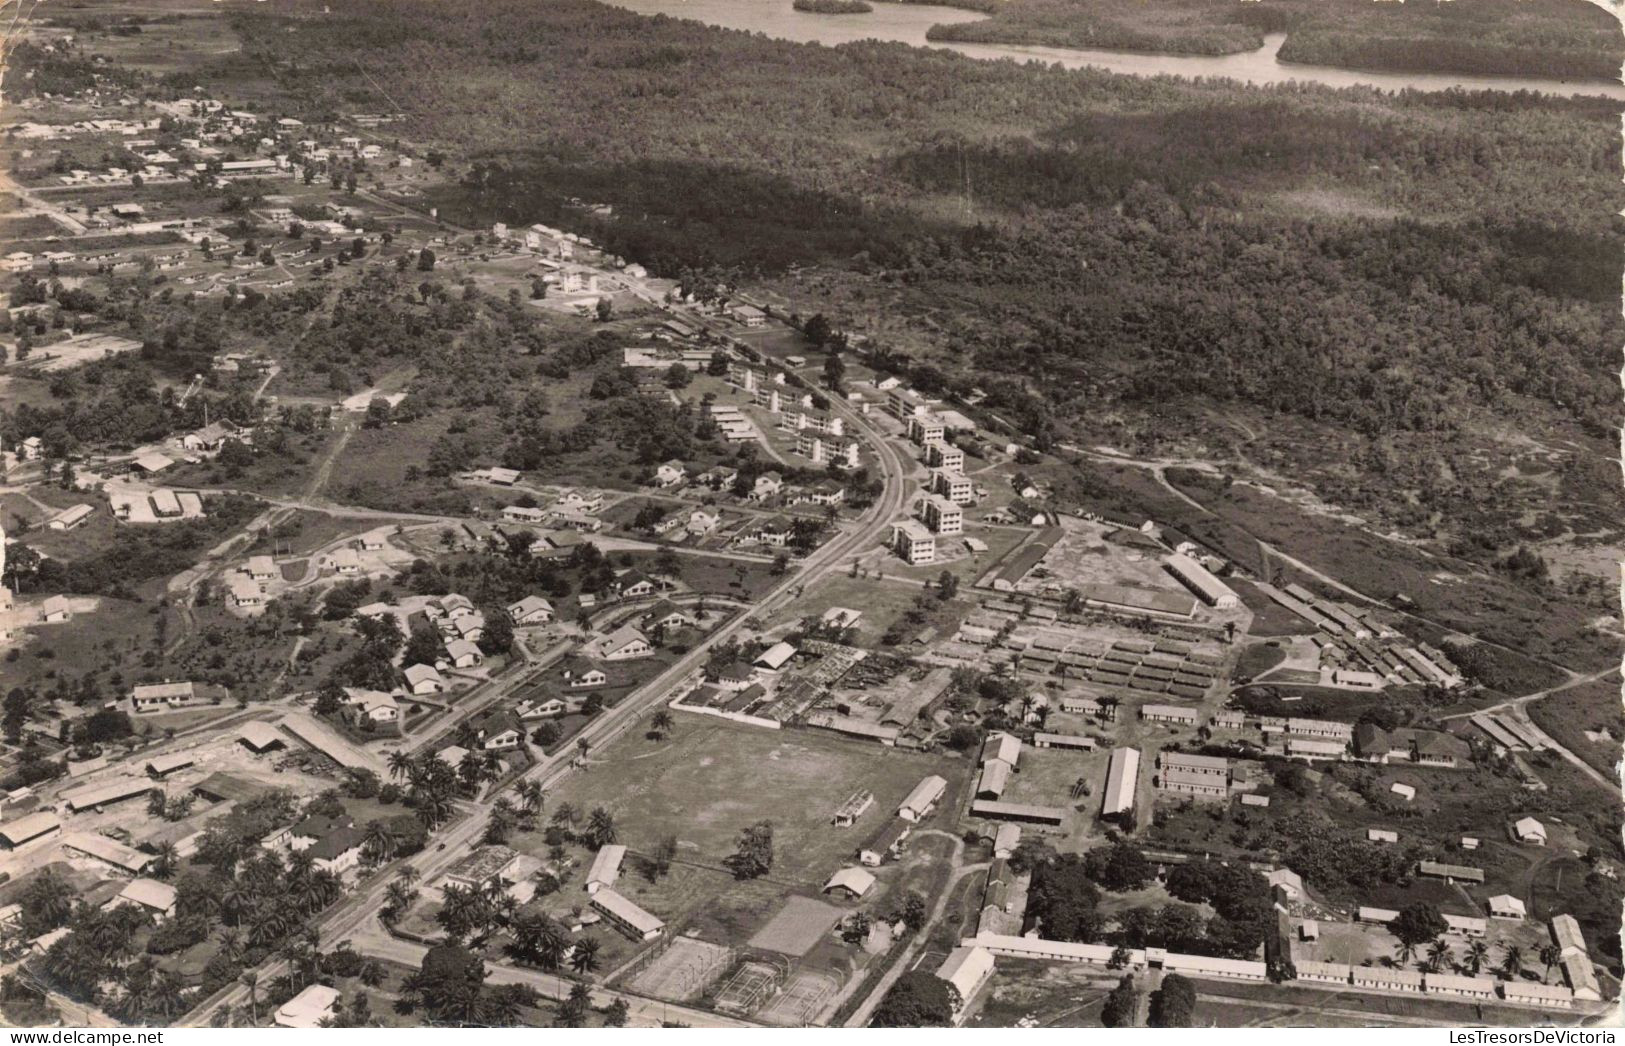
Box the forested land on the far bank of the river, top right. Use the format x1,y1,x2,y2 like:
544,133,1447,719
928,0,1625,80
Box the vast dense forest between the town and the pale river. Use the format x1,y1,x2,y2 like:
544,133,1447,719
237,0,1620,439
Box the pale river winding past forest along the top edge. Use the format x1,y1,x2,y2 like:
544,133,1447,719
606,0,1625,101
